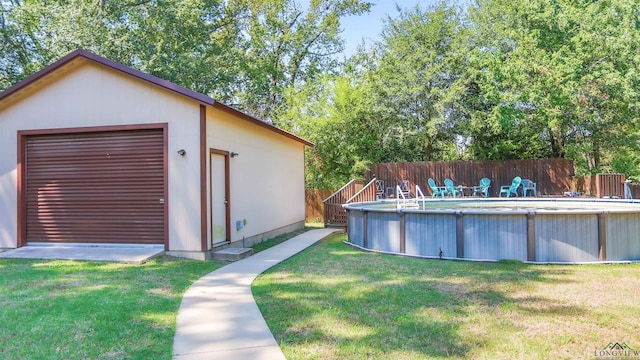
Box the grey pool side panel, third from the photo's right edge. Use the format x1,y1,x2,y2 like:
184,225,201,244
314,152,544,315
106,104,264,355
464,214,527,261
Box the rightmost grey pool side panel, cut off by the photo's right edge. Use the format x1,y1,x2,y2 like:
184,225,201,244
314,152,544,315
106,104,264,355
606,214,640,261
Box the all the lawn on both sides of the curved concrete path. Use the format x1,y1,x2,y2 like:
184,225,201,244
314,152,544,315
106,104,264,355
0,229,640,359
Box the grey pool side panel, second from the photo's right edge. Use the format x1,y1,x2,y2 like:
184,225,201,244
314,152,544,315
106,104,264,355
536,214,598,262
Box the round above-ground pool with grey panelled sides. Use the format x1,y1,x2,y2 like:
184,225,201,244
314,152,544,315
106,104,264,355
344,198,640,263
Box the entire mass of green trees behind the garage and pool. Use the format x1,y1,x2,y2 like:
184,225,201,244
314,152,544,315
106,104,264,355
0,0,640,188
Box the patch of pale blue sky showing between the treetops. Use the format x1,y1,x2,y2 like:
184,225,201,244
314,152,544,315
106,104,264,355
342,0,465,56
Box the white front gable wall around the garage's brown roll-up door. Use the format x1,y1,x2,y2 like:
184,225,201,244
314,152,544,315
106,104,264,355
0,64,200,251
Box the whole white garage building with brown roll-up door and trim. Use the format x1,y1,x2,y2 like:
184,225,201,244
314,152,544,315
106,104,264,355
0,50,313,259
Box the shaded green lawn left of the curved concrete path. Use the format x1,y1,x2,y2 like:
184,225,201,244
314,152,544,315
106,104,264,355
0,257,225,359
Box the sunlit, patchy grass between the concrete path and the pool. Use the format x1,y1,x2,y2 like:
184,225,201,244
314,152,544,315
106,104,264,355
252,234,640,359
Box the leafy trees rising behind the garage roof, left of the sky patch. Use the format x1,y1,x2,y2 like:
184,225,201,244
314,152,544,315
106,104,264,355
0,0,370,120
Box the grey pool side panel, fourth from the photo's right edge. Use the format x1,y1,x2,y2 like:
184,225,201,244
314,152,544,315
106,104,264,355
405,212,456,258
